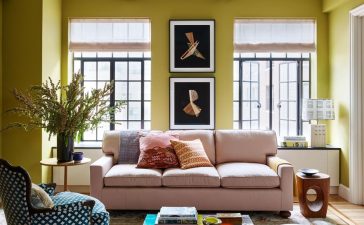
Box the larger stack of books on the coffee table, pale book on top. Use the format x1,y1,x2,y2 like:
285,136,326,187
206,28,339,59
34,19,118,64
156,207,198,225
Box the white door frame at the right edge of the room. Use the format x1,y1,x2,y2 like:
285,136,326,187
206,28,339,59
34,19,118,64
349,5,364,204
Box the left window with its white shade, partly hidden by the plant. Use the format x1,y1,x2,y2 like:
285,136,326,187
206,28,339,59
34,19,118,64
69,19,151,141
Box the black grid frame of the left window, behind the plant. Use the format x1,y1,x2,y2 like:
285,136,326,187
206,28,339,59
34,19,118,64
73,52,152,142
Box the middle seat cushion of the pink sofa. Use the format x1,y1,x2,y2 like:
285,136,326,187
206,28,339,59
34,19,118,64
162,167,220,187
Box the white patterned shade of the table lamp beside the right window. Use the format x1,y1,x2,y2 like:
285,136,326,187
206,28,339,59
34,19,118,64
302,99,335,121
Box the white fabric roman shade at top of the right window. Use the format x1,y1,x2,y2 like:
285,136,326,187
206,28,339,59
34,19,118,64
234,19,316,52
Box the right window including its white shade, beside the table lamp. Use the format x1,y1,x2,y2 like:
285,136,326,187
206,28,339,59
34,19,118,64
233,20,315,136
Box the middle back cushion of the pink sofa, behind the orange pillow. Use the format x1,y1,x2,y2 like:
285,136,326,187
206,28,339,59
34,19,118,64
168,130,215,165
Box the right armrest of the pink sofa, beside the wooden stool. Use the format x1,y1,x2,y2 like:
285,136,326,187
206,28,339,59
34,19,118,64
267,156,294,210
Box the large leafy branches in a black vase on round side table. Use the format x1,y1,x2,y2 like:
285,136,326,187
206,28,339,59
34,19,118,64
7,73,123,162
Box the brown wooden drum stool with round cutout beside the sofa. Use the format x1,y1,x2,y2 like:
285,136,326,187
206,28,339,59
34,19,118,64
296,172,330,218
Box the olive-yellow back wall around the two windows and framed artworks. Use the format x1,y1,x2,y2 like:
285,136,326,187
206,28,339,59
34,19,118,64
62,0,329,130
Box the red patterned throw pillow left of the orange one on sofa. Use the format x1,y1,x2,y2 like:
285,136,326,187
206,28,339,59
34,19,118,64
137,133,179,169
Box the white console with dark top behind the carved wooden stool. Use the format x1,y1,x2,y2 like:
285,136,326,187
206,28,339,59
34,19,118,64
277,146,341,194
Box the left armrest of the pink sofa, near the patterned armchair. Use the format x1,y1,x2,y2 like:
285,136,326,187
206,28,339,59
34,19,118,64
90,155,113,199
